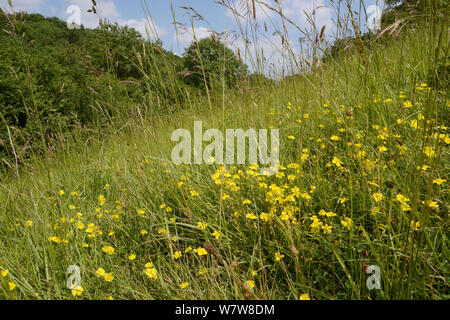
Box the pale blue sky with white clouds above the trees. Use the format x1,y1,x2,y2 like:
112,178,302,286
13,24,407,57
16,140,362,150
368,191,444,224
0,0,383,73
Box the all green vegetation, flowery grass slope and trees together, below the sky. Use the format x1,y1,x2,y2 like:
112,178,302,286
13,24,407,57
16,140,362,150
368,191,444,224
0,1,450,300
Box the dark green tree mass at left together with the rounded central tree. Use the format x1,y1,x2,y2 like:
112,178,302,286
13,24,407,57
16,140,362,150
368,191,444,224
0,11,245,165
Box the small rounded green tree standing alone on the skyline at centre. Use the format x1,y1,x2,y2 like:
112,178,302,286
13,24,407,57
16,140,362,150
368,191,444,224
184,38,247,88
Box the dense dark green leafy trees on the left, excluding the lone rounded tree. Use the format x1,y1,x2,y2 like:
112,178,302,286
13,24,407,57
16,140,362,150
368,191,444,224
0,10,171,163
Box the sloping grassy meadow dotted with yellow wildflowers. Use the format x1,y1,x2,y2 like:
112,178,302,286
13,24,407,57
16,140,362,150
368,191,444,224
0,0,450,299
